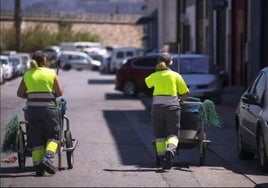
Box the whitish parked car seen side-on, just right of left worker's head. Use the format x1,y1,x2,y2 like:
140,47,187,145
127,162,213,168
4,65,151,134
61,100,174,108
60,51,101,70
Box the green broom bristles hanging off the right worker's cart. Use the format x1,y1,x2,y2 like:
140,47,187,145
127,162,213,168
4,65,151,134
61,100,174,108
202,99,222,127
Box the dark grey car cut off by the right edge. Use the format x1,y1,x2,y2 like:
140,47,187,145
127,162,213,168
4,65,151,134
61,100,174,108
235,67,268,172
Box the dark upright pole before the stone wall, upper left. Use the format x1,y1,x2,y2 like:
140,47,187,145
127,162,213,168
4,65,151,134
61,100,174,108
14,0,22,52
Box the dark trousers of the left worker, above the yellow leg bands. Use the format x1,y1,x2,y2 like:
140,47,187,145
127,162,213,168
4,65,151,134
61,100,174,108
25,106,60,148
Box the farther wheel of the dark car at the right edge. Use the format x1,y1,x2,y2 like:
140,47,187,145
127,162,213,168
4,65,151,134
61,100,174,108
236,126,254,160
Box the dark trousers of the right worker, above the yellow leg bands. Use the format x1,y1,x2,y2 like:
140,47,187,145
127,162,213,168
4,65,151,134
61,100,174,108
151,104,181,149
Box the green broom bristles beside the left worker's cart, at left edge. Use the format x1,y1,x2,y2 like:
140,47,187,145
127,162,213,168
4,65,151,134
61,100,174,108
2,114,20,152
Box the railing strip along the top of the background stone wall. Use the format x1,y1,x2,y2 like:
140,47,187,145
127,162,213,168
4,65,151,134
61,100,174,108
0,10,142,24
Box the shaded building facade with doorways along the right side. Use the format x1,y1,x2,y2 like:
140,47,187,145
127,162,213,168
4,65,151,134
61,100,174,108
138,0,268,87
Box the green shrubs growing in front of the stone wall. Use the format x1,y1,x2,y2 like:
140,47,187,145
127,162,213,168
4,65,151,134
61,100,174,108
0,23,100,52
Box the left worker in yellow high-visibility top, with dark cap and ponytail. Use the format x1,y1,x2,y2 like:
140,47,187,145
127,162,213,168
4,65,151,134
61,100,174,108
17,51,63,176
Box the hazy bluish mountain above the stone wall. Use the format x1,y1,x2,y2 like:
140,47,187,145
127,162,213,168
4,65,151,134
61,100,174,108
0,0,144,15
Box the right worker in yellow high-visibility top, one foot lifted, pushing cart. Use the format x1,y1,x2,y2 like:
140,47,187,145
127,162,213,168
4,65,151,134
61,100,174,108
145,53,189,169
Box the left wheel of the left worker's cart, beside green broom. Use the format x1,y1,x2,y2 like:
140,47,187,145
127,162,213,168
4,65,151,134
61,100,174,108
17,127,26,169
